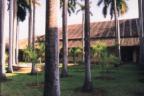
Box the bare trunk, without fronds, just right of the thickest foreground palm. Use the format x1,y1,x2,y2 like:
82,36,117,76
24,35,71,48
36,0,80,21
61,0,68,77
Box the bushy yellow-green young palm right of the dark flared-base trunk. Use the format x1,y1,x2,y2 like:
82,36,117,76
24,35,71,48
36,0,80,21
91,42,120,71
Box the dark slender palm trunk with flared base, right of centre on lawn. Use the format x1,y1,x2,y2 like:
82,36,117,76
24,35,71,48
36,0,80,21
82,0,93,92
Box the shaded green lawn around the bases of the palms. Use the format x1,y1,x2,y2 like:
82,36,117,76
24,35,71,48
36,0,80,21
1,64,144,96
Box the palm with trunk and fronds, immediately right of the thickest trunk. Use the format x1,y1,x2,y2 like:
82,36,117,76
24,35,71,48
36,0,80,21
60,0,76,77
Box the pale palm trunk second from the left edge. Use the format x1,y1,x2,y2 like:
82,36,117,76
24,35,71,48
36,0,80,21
7,0,13,73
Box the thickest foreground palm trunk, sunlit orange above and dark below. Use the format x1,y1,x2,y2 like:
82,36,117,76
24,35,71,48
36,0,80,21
44,0,60,96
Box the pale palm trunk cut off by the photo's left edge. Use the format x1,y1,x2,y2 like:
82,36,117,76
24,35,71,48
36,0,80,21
0,0,6,79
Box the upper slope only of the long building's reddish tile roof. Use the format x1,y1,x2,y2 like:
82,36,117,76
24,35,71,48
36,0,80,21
59,19,139,39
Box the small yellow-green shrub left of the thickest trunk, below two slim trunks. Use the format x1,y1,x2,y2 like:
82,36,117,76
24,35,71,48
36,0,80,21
24,47,38,62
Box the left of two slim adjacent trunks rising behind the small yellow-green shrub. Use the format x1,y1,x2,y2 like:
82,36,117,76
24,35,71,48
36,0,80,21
28,0,33,47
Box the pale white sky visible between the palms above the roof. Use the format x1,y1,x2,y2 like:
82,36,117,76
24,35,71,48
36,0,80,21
5,0,138,39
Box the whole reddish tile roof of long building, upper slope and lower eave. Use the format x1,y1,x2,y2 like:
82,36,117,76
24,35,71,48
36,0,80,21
37,19,139,47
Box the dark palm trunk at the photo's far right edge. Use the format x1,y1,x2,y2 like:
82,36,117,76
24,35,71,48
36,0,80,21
138,0,144,65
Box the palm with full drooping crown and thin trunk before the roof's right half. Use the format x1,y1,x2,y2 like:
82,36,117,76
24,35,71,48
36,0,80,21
98,0,128,61
